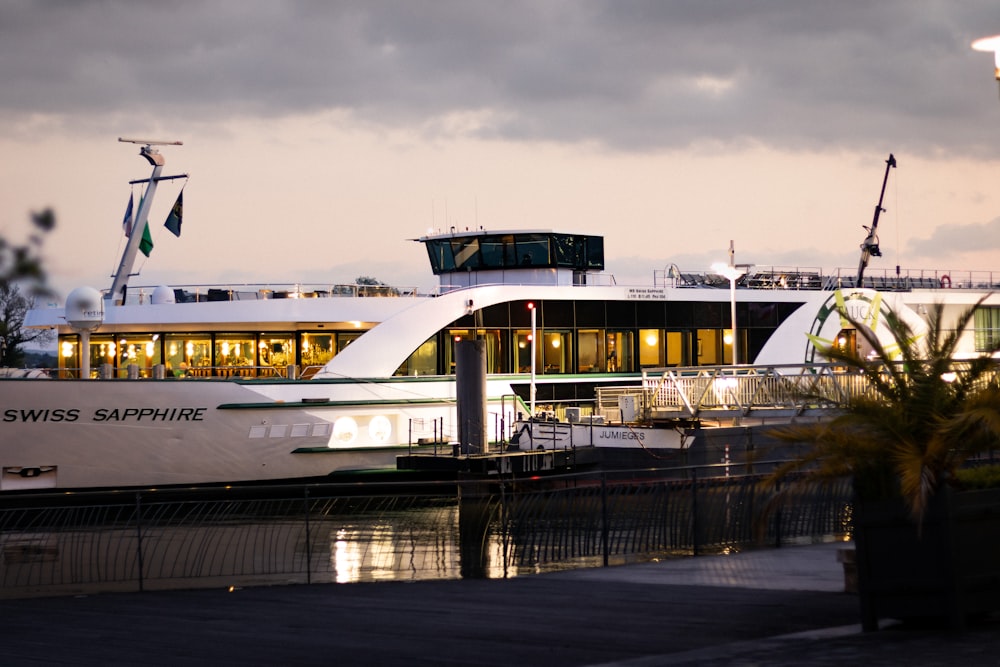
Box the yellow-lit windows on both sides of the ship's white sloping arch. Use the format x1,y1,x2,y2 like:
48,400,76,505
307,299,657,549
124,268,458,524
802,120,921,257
59,328,747,377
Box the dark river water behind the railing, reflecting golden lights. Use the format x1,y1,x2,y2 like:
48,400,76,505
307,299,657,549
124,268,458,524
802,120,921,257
0,478,842,598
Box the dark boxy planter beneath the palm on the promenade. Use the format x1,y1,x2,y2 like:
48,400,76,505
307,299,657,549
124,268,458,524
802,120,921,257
854,488,1000,632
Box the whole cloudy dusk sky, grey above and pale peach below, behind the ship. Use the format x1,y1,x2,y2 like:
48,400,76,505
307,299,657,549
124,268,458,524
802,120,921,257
0,0,1000,293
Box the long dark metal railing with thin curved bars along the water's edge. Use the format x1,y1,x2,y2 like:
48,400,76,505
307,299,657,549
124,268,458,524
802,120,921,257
0,468,850,597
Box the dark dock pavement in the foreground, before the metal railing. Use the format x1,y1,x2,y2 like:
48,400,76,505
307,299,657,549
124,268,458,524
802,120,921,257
0,543,1000,667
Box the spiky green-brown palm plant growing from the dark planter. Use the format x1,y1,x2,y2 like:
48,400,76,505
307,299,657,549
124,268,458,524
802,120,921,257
774,297,1000,524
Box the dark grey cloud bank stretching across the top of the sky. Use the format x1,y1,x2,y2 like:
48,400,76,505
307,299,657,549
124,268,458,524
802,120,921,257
0,0,1000,152
